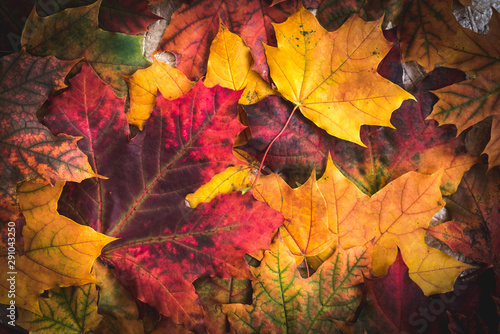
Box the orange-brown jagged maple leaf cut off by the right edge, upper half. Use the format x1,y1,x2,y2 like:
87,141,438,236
429,11,500,169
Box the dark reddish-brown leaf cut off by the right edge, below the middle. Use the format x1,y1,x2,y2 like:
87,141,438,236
428,165,500,290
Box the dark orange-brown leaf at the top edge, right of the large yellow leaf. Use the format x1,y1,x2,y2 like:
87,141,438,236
398,0,460,72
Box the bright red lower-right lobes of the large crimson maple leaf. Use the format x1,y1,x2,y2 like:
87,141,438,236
104,194,282,328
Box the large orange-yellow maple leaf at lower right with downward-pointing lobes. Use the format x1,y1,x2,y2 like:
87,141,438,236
339,170,470,295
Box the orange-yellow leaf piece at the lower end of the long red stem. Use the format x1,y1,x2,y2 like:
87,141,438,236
253,171,334,263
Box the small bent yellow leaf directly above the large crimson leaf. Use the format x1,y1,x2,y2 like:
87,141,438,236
124,57,194,130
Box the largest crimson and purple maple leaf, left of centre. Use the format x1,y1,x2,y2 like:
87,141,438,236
46,73,282,330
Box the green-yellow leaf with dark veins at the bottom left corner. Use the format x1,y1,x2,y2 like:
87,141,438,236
16,284,102,334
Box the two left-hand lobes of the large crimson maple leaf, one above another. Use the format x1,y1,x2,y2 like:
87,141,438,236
44,64,129,232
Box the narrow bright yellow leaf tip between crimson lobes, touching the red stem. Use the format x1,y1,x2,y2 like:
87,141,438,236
186,165,255,209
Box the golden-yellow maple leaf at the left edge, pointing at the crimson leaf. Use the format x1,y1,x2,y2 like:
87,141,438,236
0,182,115,315
